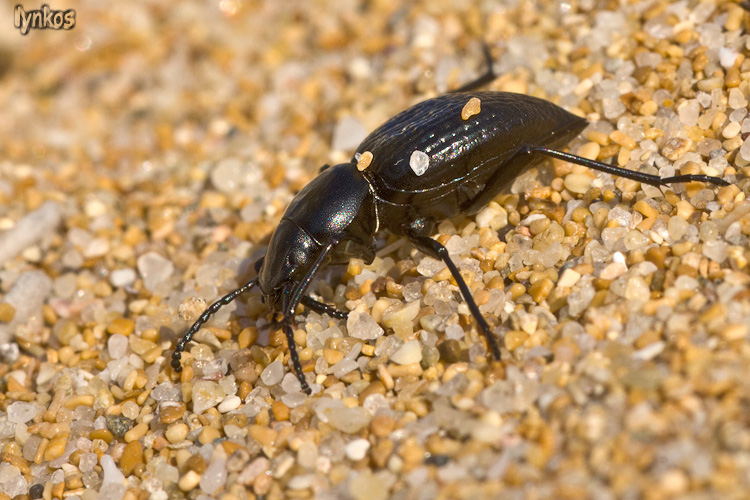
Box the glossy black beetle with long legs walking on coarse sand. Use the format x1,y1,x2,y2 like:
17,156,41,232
172,70,729,394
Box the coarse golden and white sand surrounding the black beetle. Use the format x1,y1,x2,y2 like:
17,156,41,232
0,0,750,500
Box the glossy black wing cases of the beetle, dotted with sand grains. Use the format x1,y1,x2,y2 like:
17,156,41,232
357,92,587,230
